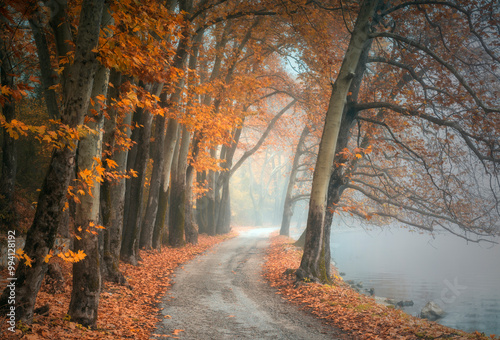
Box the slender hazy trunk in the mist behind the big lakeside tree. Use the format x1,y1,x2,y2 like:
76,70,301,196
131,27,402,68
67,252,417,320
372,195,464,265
280,126,309,236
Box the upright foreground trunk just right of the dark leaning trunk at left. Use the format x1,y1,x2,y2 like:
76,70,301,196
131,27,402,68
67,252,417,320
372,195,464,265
68,58,109,327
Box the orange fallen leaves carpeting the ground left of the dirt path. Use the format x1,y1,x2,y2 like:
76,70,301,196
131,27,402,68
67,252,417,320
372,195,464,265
0,232,237,340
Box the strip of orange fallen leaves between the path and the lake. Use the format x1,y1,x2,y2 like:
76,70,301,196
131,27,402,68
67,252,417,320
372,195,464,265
264,236,500,340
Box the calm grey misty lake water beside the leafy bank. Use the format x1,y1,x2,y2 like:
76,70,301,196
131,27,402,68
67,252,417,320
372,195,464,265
331,227,500,335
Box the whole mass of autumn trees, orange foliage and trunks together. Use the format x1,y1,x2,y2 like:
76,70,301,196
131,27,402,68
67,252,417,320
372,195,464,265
0,0,500,332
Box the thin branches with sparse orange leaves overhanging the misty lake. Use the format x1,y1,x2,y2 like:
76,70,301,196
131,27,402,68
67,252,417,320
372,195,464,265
299,2,498,280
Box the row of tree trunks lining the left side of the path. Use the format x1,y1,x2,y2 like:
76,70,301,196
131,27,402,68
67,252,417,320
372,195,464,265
2,0,293,326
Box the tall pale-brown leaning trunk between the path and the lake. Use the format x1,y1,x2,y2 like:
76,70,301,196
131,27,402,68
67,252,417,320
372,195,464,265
297,0,378,282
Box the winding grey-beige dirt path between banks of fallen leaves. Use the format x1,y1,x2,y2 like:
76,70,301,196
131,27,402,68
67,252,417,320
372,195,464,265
152,228,346,340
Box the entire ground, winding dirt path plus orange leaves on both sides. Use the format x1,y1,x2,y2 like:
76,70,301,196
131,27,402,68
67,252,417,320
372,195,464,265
0,228,499,340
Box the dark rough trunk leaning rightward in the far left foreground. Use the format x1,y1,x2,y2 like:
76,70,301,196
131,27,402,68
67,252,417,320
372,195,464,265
0,0,104,323
